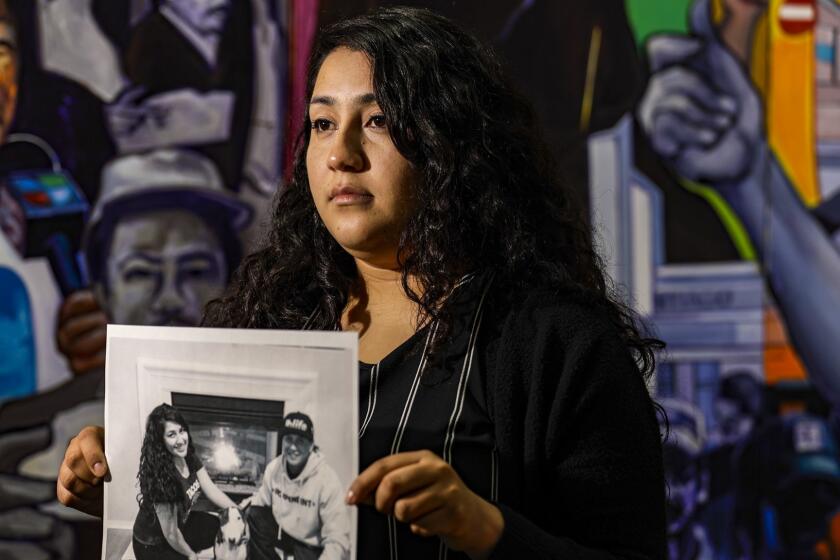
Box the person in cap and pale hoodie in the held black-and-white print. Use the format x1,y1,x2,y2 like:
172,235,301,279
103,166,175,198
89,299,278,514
247,412,350,560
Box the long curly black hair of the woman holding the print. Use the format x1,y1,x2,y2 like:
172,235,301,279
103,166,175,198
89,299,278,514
204,7,660,377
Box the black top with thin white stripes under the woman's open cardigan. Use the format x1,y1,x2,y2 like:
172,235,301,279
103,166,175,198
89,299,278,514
358,280,496,560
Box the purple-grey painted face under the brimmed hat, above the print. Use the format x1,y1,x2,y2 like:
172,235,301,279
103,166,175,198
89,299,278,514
106,210,227,326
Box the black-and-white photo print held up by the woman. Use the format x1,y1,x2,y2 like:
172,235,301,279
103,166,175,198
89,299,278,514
102,325,359,560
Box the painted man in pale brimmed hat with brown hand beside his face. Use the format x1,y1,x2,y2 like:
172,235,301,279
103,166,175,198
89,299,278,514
57,149,252,374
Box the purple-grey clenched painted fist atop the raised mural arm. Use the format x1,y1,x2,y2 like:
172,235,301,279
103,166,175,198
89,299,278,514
637,0,765,189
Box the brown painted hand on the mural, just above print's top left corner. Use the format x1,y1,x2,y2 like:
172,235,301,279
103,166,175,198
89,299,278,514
56,290,108,375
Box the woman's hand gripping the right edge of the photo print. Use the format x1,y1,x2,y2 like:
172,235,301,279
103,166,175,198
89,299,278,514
347,451,504,559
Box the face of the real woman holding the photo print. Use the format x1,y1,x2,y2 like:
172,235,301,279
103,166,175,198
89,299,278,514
306,48,417,268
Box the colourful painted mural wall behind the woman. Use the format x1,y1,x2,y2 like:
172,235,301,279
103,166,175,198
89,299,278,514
0,0,840,559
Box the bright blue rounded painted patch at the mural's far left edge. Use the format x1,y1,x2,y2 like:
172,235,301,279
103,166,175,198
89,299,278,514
0,267,36,399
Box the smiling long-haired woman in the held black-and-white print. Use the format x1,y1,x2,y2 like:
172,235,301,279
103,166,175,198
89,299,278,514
132,404,236,560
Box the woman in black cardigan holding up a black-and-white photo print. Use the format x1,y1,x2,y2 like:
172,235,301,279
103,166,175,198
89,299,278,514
58,8,665,560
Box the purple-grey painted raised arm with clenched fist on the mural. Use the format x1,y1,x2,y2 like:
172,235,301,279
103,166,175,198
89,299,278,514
637,0,840,403
